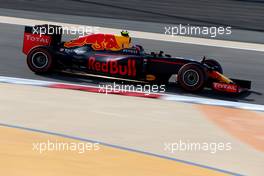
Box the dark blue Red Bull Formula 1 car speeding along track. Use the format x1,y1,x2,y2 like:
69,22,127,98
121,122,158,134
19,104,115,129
23,25,251,93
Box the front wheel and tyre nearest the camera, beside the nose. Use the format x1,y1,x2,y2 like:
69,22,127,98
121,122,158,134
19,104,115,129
177,63,207,92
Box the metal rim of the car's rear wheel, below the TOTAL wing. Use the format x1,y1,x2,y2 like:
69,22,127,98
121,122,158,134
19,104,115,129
31,52,49,69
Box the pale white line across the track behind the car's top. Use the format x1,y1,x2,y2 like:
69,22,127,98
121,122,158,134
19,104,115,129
0,16,264,52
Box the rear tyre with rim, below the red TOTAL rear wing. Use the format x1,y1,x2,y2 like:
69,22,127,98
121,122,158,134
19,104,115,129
27,48,54,74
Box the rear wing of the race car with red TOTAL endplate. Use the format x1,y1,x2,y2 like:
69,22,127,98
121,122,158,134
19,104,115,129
23,24,62,55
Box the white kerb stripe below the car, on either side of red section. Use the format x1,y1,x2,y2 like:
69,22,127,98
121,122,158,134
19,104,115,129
0,76,264,112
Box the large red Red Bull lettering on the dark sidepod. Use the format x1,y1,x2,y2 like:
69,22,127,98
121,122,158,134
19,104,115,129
88,57,136,77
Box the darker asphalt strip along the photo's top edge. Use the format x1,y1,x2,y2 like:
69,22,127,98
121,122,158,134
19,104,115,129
0,0,264,31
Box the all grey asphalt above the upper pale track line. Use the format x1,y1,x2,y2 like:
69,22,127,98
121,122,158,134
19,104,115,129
0,0,264,43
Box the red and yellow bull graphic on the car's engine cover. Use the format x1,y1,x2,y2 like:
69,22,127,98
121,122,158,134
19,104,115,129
64,34,130,51
